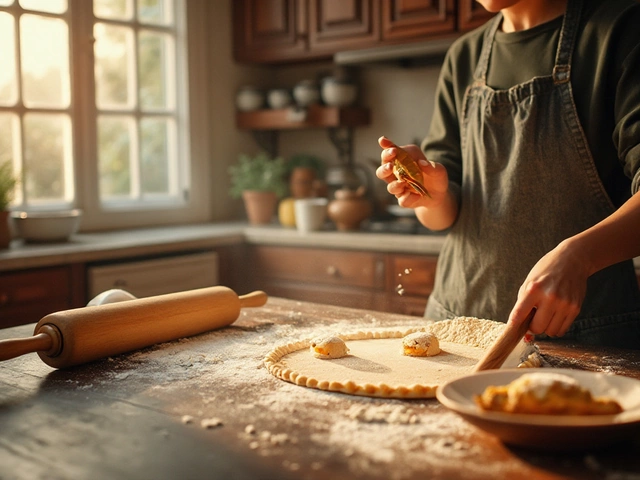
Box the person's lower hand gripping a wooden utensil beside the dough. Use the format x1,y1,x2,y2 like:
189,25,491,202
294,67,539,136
509,242,589,337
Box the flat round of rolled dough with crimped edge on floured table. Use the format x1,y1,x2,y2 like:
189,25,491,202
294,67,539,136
264,317,532,398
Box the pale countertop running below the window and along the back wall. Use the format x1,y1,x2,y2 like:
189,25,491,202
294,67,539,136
0,223,640,272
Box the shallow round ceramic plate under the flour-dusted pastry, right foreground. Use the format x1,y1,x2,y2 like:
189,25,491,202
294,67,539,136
436,368,640,450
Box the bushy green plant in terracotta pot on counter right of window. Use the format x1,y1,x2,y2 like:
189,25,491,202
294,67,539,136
229,152,287,225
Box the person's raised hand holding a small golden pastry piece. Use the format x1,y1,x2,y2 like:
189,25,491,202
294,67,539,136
376,137,449,208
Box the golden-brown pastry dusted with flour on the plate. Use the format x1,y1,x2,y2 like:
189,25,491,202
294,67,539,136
473,372,622,415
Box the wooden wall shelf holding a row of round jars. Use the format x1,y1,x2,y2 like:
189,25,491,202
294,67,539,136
236,105,371,130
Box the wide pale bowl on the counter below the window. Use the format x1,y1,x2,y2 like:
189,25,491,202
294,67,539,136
11,209,82,242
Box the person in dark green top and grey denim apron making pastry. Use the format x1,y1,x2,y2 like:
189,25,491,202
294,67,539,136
376,0,640,348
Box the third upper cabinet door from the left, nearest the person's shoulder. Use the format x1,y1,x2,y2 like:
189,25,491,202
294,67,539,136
382,0,456,41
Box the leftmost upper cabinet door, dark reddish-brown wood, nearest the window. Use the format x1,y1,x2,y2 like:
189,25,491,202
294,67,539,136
231,0,307,62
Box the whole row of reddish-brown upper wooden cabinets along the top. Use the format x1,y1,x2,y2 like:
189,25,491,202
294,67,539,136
230,0,491,63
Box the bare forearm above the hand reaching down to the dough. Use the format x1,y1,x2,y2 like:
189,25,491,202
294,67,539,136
561,192,640,274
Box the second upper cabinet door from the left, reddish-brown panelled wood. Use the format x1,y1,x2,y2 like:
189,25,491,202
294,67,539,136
309,0,380,54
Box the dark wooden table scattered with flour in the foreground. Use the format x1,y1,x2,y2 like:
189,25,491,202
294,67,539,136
0,298,640,480
